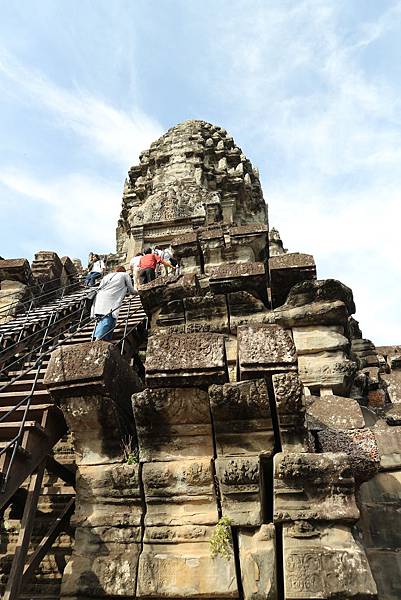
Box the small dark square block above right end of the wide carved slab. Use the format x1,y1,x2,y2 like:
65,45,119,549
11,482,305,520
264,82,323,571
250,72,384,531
184,293,229,333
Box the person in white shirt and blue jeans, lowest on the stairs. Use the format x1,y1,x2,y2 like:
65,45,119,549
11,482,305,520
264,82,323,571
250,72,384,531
91,267,138,341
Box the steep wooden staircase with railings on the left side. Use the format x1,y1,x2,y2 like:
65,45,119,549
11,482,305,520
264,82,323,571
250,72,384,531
0,287,146,600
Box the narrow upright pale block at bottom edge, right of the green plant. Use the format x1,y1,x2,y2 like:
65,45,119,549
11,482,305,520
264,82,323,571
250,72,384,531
238,523,277,600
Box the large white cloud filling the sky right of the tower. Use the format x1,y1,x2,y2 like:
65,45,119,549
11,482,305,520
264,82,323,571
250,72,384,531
206,0,401,343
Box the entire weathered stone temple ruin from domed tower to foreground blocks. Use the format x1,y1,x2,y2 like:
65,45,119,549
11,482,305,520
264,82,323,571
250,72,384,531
0,121,401,600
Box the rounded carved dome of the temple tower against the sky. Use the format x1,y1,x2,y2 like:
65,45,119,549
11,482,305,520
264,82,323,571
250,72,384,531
117,121,267,255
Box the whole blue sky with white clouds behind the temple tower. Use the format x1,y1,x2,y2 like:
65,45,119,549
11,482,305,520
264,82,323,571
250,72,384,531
0,0,401,344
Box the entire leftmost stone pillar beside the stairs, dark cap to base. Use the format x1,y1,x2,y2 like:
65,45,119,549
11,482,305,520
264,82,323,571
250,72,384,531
45,342,143,599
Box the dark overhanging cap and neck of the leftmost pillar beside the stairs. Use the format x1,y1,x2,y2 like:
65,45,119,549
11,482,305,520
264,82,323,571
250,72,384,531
44,341,141,464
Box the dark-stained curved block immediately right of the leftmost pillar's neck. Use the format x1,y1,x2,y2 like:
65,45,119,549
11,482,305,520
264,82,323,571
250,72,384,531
132,388,214,461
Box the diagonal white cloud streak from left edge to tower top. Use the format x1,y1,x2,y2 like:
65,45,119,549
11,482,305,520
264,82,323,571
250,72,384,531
0,47,162,168
